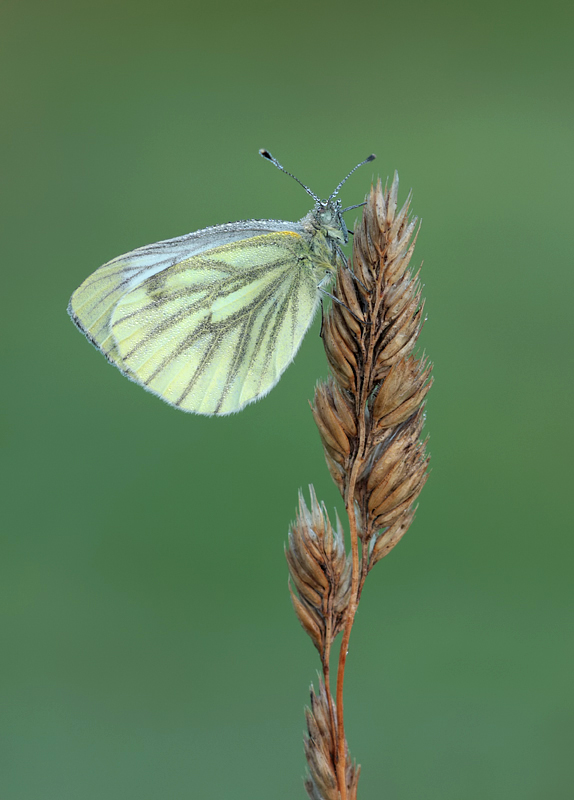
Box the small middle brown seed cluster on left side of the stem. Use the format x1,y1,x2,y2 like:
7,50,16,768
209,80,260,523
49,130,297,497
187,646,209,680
285,486,351,659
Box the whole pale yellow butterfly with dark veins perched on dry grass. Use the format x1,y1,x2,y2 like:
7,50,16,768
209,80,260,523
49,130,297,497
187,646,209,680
68,150,374,415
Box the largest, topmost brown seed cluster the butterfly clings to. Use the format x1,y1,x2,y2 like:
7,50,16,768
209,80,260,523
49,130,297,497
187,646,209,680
313,173,432,564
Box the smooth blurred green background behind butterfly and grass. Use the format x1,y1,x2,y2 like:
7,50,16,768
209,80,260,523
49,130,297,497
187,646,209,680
0,0,574,800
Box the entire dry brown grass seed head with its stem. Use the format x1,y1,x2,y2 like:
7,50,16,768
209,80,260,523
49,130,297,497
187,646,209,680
287,173,432,800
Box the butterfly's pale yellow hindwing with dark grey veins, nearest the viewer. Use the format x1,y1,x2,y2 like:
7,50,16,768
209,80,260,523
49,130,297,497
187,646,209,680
108,232,324,414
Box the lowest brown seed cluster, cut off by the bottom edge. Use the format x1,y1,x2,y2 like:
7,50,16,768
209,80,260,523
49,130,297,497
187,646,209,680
305,680,361,800
